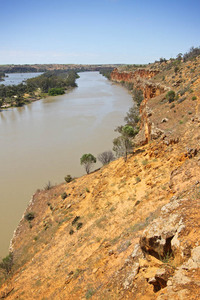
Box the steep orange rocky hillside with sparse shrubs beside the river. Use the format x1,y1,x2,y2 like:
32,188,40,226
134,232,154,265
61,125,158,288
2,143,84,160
0,57,200,300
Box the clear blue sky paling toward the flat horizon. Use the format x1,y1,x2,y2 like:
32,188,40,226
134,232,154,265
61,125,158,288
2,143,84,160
0,0,200,64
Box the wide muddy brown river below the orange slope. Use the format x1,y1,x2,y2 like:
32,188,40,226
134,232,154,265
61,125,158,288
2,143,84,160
0,72,132,257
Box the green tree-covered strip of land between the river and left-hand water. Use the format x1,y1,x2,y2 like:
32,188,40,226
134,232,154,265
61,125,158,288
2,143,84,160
0,70,79,107
